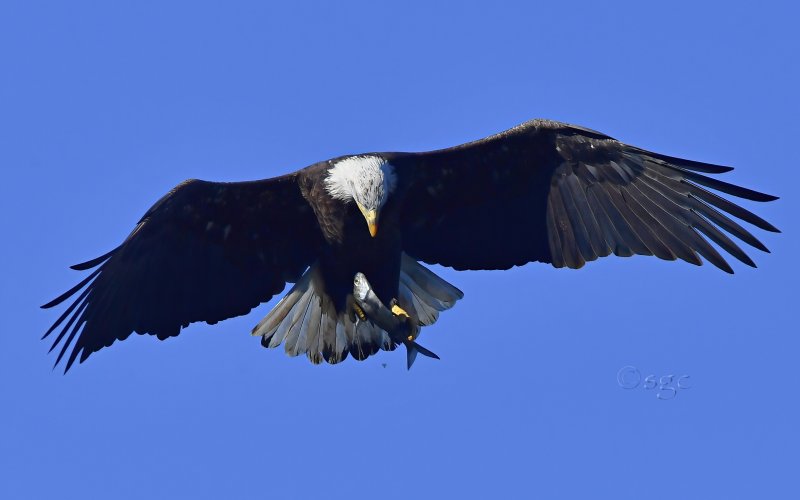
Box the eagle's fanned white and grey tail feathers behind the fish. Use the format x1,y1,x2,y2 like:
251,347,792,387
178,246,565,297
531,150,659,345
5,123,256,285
252,254,464,364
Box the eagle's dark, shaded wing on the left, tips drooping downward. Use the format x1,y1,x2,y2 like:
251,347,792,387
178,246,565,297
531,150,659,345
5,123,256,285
42,174,322,372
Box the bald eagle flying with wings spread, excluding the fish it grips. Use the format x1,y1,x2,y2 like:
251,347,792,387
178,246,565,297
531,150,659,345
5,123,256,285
42,120,778,372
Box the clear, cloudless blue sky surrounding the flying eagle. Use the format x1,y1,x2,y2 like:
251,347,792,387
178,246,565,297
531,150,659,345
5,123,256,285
0,0,800,500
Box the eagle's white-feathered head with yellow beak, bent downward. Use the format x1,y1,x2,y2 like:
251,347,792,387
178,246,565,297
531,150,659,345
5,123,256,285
325,155,397,237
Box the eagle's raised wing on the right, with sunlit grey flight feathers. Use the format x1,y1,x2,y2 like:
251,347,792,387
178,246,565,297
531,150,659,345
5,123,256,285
396,120,778,273
